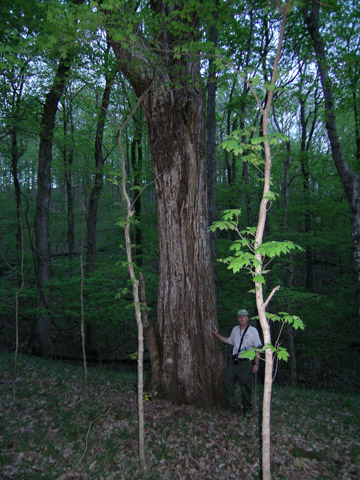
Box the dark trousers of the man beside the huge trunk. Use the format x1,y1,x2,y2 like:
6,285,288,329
224,359,253,413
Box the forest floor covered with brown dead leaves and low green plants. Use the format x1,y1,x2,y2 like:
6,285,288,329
0,354,360,480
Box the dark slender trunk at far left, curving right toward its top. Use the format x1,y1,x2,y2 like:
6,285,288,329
33,56,71,356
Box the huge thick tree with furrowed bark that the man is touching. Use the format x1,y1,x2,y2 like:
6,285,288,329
107,0,223,406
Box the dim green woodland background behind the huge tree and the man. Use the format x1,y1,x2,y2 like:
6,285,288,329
0,0,360,391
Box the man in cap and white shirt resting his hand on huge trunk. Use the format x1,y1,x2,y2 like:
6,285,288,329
213,310,262,418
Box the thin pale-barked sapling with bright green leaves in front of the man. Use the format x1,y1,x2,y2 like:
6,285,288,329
212,1,302,480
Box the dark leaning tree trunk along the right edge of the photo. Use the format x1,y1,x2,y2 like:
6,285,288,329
305,0,360,335
